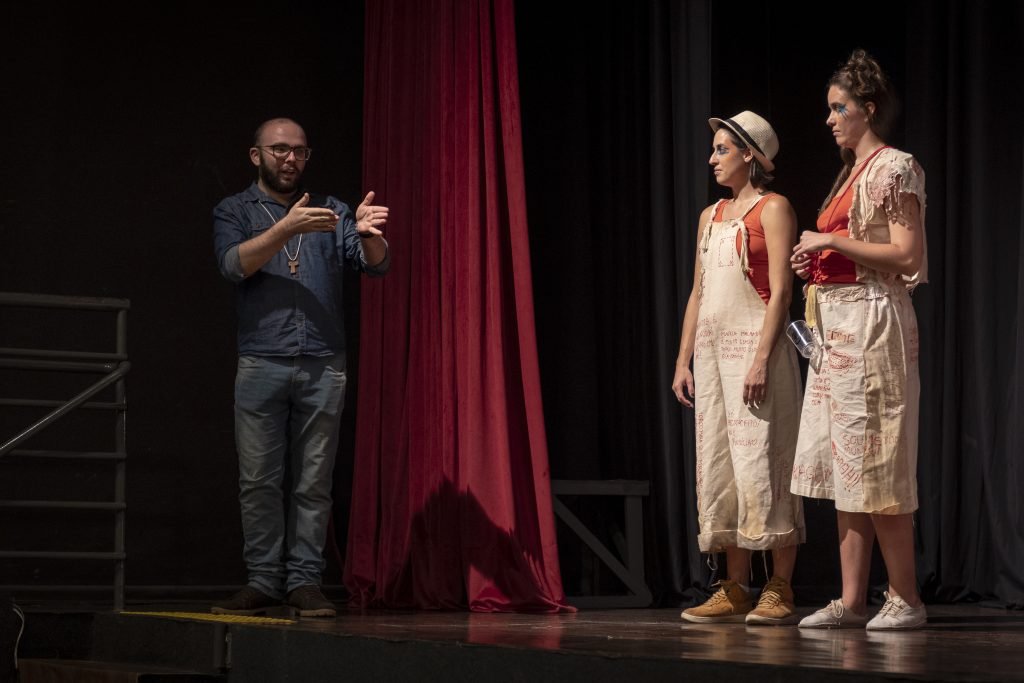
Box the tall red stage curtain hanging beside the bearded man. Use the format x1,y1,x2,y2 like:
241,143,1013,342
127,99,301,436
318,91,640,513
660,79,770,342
344,0,570,612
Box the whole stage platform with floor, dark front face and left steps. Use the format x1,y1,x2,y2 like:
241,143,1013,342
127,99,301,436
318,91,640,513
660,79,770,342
14,603,1024,683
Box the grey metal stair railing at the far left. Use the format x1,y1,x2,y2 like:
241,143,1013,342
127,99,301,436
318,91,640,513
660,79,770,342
0,292,131,610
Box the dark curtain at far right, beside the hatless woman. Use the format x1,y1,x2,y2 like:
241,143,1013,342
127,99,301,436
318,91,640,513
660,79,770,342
905,0,1024,608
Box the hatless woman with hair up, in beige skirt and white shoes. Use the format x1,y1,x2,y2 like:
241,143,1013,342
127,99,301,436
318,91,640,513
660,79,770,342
792,50,927,630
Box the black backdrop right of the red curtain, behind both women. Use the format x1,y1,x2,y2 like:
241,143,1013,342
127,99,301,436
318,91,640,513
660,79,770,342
518,0,1024,605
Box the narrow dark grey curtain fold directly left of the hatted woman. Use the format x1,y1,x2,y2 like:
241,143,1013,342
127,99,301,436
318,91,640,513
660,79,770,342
646,2,711,603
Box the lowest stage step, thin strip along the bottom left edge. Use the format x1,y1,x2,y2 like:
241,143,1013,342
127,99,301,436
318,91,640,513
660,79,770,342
18,659,227,683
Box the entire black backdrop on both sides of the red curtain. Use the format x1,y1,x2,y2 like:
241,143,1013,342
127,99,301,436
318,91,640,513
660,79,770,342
0,0,1024,605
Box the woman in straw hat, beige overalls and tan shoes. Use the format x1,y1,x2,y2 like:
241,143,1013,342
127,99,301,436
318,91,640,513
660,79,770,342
672,112,805,624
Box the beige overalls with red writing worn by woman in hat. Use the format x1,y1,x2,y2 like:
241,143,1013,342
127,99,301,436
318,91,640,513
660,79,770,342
693,197,805,552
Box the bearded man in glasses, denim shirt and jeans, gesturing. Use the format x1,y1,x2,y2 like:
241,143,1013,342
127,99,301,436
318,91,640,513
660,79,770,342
212,119,390,617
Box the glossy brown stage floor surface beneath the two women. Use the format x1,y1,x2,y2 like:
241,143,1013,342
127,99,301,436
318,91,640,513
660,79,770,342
243,605,1024,681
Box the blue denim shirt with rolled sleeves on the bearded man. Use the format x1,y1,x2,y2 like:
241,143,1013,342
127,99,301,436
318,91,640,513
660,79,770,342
213,182,391,356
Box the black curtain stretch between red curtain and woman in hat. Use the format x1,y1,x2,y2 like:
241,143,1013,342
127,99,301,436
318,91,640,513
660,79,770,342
518,0,711,604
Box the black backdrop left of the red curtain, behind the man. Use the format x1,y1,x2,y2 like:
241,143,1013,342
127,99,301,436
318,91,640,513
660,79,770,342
0,0,364,586
